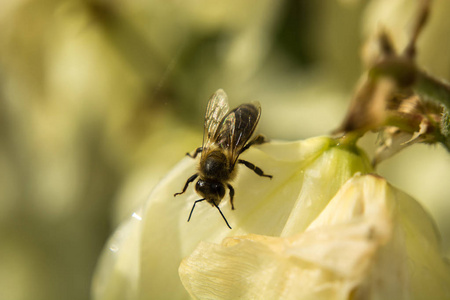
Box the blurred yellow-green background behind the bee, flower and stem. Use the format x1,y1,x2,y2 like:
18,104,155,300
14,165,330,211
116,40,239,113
0,0,450,300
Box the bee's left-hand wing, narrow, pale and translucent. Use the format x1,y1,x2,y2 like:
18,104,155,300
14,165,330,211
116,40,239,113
203,89,229,153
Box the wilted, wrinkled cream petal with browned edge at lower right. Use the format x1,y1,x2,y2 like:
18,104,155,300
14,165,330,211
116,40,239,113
179,175,450,299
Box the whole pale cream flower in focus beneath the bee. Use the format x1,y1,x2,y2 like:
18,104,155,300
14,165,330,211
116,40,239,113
89,137,450,300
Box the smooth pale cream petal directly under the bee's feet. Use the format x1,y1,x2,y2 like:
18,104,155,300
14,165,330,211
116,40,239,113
90,137,371,299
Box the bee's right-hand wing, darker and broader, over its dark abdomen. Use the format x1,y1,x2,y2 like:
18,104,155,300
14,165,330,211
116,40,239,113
214,102,261,165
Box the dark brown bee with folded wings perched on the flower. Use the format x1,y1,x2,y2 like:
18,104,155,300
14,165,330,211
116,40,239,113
174,89,272,229
